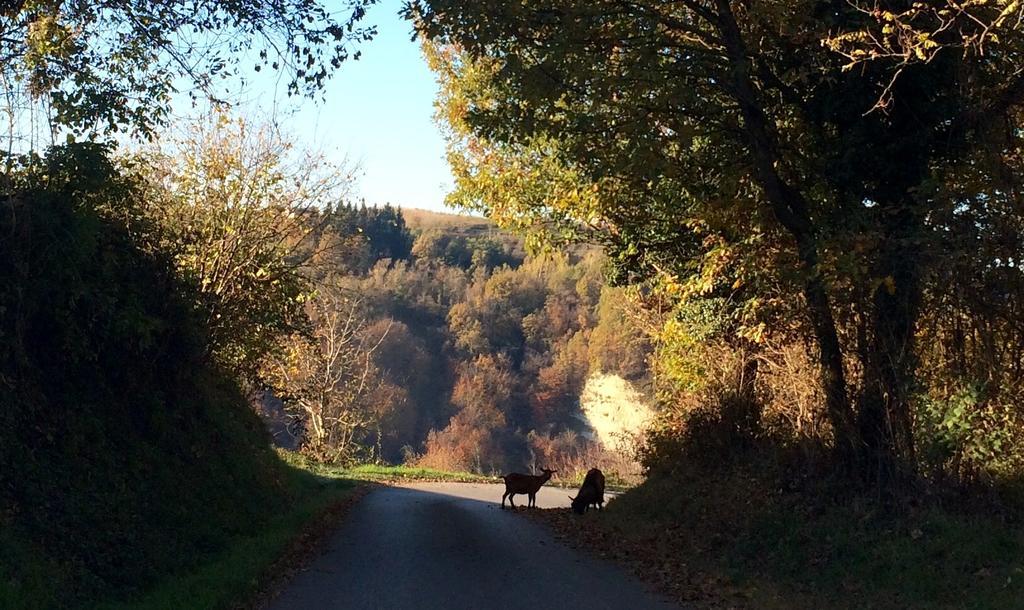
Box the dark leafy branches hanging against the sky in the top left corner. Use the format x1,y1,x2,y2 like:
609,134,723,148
0,0,374,135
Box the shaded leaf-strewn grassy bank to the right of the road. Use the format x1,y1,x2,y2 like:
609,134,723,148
540,469,1024,608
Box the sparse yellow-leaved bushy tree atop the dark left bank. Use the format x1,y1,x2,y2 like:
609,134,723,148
146,115,350,381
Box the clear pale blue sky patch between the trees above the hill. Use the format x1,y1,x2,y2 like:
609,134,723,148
238,0,452,210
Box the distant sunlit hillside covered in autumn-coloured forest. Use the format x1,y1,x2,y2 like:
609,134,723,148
267,204,649,477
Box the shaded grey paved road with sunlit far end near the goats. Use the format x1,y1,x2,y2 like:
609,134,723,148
270,483,675,610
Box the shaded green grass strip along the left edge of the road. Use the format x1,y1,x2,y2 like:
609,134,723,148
0,444,364,609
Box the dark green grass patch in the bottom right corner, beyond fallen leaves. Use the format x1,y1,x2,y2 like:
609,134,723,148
730,495,1024,608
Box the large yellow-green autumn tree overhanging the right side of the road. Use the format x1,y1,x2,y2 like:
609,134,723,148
409,0,1022,476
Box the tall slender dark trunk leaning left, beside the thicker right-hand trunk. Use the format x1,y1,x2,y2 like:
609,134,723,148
716,0,861,466
